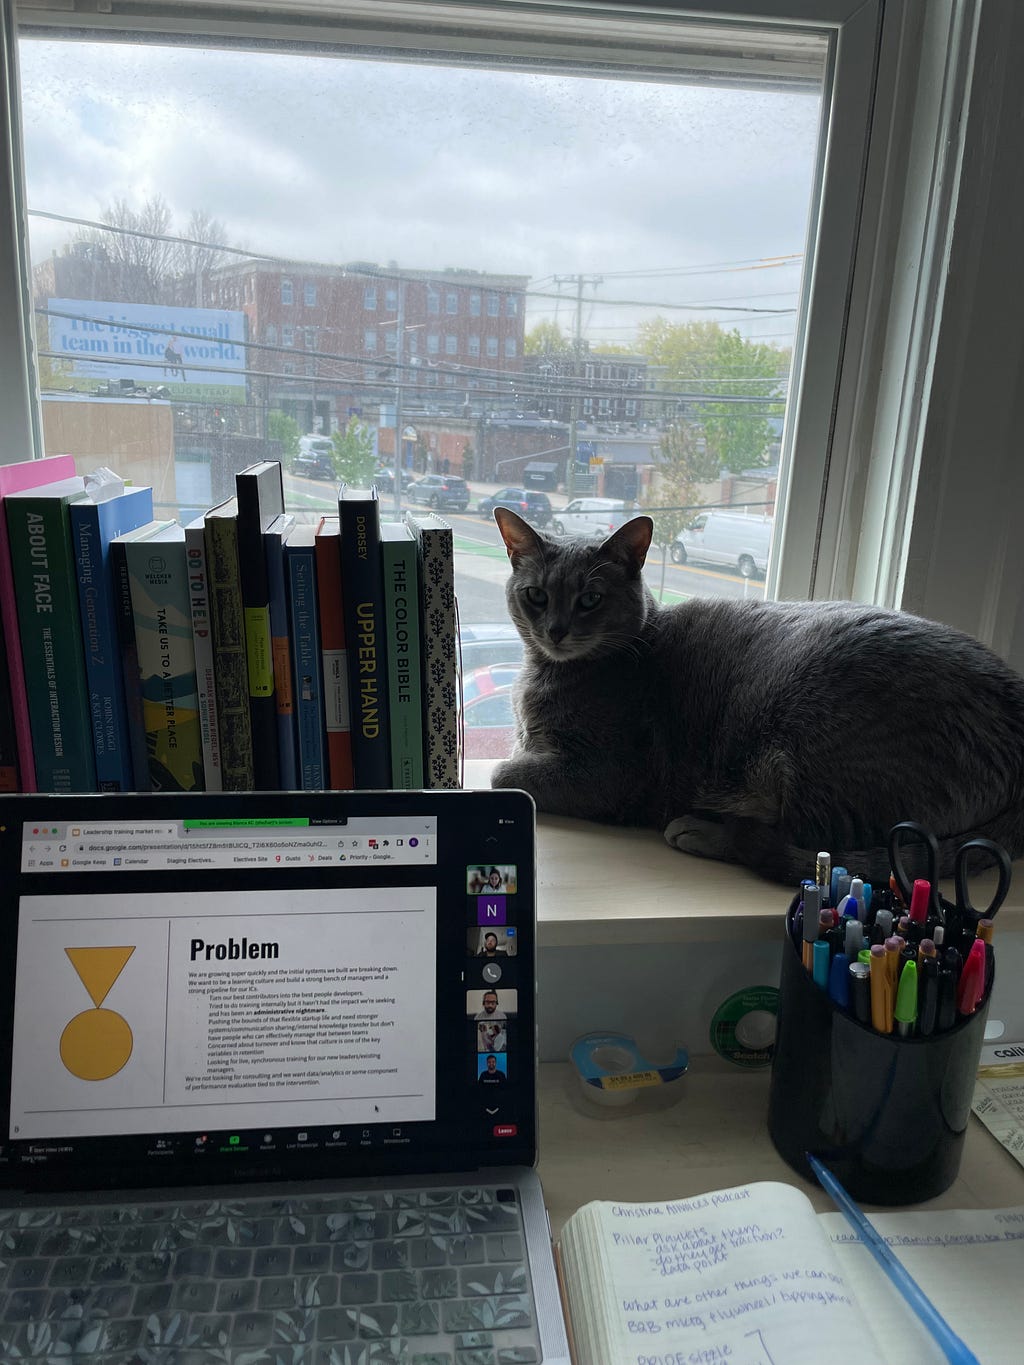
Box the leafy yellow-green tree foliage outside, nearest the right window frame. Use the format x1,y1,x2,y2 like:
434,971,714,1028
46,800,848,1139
638,318,791,478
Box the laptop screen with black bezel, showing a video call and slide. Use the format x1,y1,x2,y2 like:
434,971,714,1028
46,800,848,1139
0,792,535,1189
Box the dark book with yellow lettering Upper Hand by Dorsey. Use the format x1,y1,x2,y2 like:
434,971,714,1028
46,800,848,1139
337,487,390,788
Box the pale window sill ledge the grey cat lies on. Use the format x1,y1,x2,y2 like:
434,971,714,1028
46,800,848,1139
464,759,1024,947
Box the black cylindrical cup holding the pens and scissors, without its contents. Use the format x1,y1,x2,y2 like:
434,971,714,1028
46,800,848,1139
769,901,991,1204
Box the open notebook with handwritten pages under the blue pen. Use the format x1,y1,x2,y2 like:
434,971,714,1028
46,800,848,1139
560,1181,1024,1365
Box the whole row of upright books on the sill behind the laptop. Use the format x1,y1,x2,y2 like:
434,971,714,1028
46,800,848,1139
0,456,461,792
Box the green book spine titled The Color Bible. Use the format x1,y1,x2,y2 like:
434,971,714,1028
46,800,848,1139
381,523,423,790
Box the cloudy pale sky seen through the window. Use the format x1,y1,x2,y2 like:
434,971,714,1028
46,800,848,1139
19,40,819,347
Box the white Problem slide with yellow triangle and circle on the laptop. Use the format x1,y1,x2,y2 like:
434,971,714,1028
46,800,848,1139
10,887,437,1138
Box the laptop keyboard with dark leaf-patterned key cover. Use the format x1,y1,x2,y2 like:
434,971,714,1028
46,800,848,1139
0,1186,541,1365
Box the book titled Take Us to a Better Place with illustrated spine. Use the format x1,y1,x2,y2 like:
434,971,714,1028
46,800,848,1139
124,527,203,792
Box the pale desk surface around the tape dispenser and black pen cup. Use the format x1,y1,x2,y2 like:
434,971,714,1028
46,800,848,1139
538,1058,1024,1239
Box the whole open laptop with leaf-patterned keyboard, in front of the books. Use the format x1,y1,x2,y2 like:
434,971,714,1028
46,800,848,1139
0,792,568,1365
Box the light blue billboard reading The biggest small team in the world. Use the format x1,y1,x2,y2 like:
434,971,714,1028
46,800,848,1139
46,299,246,403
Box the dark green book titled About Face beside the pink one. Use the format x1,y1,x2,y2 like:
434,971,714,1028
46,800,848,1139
5,479,96,792
